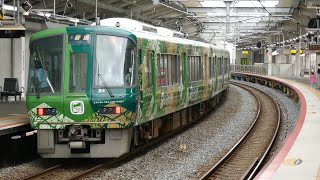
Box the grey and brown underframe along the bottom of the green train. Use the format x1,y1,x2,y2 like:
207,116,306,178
37,89,228,158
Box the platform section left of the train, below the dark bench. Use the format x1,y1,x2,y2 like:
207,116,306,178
0,101,30,136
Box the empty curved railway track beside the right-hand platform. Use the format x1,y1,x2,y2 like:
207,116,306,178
200,82,280,179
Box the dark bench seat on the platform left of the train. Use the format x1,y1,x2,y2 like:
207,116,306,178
0,78,24,102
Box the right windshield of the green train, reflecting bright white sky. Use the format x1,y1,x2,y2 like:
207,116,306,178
94,35,136,87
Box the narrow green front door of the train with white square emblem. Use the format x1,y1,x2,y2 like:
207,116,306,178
64,45,93,121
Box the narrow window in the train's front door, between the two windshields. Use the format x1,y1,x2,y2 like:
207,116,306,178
69,53,88,93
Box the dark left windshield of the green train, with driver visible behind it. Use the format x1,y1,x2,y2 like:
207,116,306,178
28,35,64,93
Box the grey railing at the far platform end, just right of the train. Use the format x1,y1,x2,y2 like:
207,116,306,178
231,64,268,75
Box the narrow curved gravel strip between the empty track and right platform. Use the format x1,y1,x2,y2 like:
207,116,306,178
235,80,300,160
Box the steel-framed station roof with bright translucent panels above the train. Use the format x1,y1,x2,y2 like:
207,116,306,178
0,0,320,47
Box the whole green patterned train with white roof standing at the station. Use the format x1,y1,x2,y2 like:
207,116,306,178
26,18,230,158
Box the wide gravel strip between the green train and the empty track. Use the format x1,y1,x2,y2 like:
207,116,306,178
91,85,257,179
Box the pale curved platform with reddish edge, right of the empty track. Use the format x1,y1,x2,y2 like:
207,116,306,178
255,77,320,180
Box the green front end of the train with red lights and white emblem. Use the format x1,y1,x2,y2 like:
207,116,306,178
27,26,137,158
